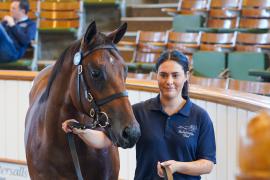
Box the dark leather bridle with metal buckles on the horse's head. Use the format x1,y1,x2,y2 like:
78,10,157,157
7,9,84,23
73,39,128,129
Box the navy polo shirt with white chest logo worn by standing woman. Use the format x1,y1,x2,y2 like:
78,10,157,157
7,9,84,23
133,95,216,180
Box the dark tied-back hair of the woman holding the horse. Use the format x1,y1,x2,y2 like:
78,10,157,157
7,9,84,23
155,50,189,98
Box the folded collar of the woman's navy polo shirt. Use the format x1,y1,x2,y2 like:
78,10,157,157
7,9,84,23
149,94,192,116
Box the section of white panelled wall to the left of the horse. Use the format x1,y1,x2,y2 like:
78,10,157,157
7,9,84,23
0,80,31,160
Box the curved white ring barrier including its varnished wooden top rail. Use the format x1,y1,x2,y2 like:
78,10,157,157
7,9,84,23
0,71,270,180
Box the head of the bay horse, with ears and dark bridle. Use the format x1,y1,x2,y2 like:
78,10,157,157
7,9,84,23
71,22,140,148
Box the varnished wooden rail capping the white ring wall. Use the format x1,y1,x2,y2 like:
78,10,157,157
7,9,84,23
0,70,270,112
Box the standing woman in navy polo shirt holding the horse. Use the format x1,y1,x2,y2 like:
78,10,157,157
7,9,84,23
64,51,216,180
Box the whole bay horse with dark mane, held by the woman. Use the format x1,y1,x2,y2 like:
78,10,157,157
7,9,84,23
24,22,140,180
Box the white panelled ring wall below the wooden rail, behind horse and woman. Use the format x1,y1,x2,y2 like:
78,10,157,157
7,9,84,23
0,80,255,180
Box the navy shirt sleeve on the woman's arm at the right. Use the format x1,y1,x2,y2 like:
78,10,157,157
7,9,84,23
197,111,216,164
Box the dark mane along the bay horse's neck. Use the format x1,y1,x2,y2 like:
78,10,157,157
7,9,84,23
40,41,80,102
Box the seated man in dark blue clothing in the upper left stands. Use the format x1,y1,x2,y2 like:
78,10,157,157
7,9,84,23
0,0,36,63
